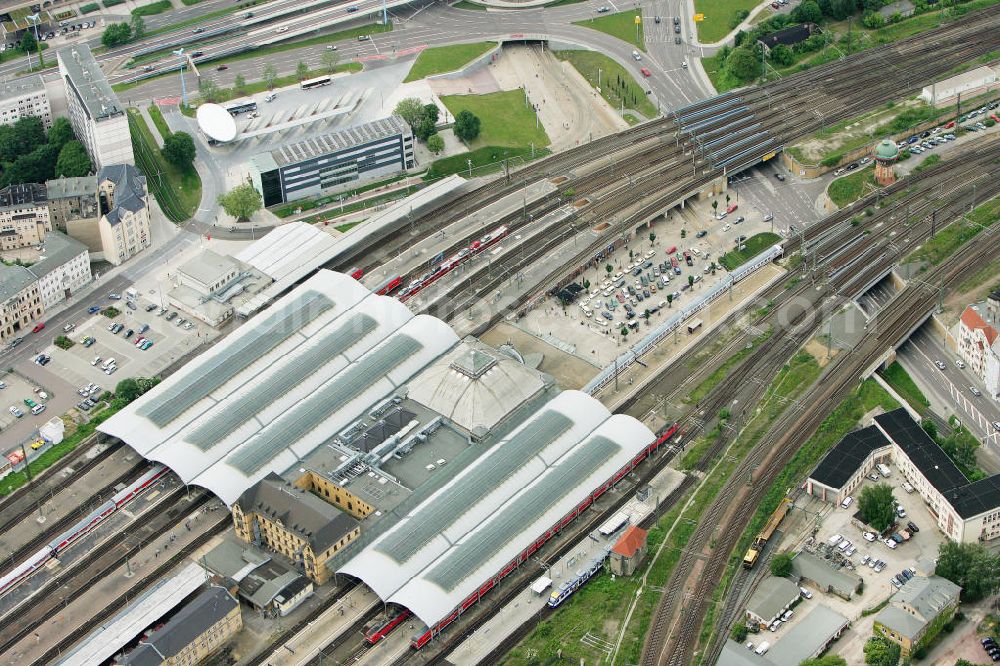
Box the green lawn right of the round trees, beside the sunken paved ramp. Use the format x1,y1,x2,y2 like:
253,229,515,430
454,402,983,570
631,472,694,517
441,90,549,148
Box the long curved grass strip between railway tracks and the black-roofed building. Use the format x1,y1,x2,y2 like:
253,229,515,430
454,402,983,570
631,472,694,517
701,379,899,656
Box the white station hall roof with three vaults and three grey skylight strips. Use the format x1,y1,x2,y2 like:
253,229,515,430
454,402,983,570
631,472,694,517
100,271,458,505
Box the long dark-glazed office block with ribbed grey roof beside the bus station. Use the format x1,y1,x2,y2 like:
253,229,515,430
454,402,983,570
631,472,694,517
250,116,414,206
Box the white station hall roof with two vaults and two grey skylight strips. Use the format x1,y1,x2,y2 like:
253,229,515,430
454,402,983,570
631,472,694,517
339,391,655,626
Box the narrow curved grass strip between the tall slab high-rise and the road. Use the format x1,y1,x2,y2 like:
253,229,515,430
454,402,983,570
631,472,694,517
128,109,201,223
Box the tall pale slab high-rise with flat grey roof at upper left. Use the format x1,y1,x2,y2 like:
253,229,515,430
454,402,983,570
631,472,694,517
56,44,135,169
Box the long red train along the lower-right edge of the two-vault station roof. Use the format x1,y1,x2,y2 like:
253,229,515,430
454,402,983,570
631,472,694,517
410,423,680,650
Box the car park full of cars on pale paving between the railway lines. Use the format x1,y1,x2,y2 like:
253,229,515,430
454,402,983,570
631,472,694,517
520,195,784,366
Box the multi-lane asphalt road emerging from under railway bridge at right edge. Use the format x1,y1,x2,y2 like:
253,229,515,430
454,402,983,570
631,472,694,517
898,326,1000,460
